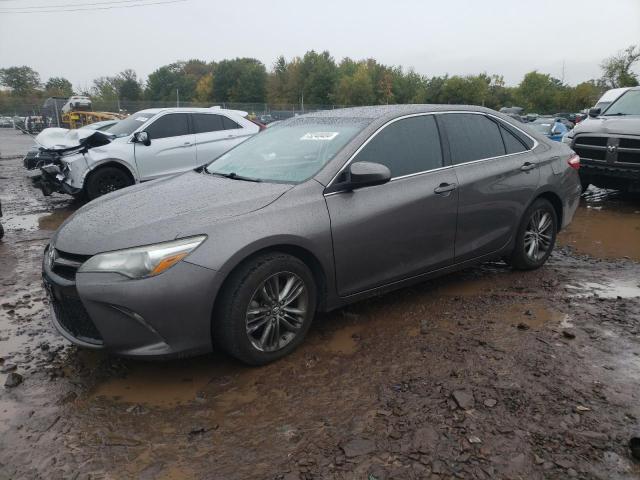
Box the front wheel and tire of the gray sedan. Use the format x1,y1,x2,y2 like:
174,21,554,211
212,252,317,365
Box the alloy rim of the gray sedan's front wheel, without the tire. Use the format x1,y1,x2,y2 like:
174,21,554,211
245,272,309,352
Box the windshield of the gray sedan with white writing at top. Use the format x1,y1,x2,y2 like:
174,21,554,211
206,118,366,183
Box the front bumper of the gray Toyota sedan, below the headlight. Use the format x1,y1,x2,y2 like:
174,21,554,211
42,249,218,359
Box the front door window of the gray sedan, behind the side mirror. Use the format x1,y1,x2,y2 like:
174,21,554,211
354,115,443,177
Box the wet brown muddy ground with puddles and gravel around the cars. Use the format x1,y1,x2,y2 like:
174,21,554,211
0,131,640,480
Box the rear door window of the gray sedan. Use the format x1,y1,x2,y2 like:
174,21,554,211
438,113,506,165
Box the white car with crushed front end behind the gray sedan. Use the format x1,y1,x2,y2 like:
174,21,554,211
38,108,260,200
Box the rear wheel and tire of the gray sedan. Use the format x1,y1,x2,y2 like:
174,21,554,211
510,198,558,270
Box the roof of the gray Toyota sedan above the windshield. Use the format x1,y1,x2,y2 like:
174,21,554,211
302,104,503,121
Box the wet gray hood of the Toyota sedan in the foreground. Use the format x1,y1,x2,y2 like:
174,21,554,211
52,172,292,255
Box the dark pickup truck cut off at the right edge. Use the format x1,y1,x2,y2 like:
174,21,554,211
563,87,640,192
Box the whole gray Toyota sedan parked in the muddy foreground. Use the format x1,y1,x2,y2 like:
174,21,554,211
43,105,580,365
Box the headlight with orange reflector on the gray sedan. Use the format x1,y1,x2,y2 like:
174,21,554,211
78,235,207,278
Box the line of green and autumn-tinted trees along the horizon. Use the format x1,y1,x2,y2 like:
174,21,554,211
0,46,640,113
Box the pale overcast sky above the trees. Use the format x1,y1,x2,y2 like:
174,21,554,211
0,0,640,87
